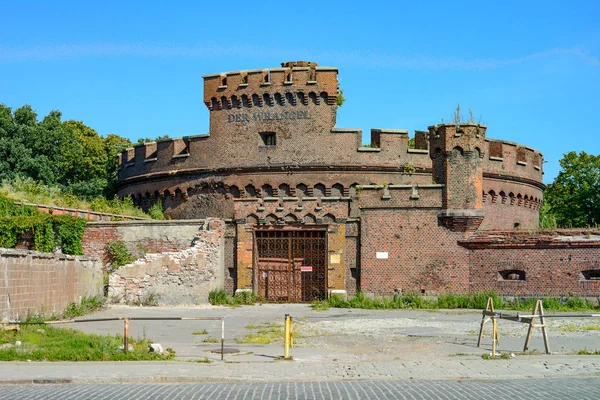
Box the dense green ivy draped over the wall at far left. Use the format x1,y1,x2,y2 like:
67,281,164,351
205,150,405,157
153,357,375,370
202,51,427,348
0,196,85,255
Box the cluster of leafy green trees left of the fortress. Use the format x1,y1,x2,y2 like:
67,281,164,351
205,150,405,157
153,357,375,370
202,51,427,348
0,104,132,199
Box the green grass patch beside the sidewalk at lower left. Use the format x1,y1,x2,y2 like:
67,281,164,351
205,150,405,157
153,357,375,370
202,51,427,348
0,325,175,361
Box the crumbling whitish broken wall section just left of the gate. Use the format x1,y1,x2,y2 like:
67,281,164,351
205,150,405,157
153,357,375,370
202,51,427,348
108,219,225,304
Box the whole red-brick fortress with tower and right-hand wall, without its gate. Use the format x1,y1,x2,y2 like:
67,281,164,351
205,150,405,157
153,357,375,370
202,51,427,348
105,62,600,296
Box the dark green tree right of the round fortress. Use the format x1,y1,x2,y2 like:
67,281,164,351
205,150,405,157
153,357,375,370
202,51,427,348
544,151,600,227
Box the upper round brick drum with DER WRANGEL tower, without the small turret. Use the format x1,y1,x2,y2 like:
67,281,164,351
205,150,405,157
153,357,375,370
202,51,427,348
119,62,543,233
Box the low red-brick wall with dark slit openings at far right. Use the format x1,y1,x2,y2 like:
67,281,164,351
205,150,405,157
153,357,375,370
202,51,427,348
460,230,600,297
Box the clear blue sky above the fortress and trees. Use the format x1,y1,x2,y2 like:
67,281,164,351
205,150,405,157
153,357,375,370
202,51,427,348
0,1,600,183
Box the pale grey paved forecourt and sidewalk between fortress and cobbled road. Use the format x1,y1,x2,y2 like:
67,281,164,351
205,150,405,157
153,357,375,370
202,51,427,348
0,304,600,384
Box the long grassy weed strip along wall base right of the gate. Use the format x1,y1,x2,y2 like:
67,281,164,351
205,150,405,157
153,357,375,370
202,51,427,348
312,292,600,311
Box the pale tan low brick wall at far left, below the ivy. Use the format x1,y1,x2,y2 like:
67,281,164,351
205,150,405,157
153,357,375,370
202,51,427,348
0,249,103,320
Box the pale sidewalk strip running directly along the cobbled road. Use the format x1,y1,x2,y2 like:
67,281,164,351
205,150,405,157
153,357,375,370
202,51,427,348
0,356,600,384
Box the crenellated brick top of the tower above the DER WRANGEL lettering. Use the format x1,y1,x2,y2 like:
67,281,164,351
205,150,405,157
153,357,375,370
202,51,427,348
203,61,338,111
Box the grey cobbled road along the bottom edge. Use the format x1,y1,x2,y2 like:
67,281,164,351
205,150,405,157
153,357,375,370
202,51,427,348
0,378,600,400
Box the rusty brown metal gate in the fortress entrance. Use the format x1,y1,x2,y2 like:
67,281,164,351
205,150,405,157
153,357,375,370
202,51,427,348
254,230,327,302
